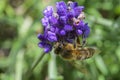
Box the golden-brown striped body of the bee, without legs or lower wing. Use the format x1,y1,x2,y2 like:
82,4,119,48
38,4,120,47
54,39,98,61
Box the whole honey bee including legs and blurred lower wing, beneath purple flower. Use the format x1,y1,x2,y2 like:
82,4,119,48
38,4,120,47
54,38,100,75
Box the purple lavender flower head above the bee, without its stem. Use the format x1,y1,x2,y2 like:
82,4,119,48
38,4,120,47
38,1,90,53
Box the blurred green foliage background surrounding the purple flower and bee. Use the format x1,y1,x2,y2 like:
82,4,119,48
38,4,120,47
0,0,120,80
